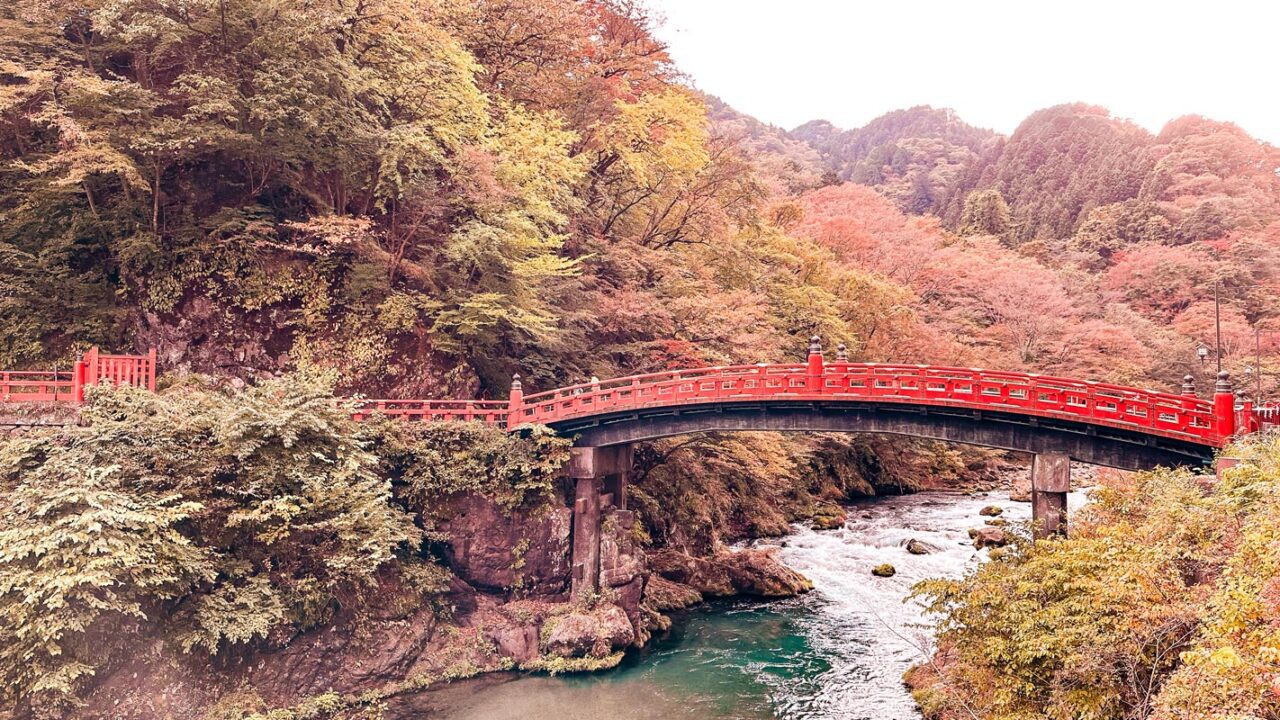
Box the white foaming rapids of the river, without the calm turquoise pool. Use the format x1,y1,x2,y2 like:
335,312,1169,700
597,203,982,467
769,492,1030,720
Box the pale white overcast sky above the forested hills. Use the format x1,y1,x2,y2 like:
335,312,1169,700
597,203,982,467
648,0,1280,145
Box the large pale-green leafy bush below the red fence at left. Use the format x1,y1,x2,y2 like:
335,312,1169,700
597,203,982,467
0,378,419,706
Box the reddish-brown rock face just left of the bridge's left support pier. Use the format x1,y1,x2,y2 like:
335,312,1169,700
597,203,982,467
440,495,572,598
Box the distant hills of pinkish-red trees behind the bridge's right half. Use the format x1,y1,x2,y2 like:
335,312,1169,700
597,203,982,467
790,105,1280,395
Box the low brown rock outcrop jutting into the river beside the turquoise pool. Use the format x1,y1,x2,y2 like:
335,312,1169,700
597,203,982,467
649,548,813,597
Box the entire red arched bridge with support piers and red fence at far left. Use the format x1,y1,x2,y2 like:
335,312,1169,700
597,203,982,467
0,338,1280,563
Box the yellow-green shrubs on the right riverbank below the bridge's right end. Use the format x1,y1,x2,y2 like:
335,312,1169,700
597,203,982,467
916,430,1280,720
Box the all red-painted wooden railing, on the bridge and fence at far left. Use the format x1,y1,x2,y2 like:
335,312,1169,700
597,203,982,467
0,347,1259,447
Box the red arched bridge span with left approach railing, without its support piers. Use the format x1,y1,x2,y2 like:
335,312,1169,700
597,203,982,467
358,338,1280,461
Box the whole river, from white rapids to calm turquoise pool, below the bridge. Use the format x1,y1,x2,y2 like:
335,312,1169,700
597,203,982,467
421,492,1082,720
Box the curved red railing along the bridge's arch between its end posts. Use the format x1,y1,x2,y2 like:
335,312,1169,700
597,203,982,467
508,363,1221,445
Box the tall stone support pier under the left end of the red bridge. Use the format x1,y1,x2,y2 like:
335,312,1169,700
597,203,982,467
568,445,631,598
